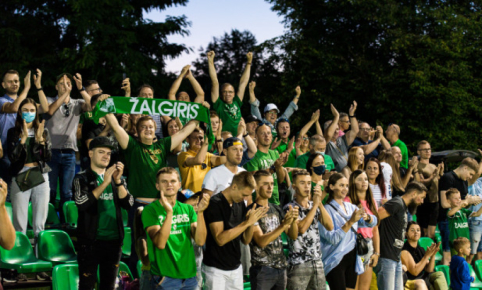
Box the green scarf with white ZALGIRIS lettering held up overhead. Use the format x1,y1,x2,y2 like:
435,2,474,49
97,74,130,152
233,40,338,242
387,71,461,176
92,97,214,144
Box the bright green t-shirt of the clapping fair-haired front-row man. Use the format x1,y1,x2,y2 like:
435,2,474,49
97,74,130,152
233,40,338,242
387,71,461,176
142,201,197,279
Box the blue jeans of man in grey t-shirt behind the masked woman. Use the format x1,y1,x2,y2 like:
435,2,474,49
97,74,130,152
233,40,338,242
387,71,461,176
48,149,75,223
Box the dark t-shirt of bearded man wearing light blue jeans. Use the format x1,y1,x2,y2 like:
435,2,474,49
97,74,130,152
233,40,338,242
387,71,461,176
380,196,407,262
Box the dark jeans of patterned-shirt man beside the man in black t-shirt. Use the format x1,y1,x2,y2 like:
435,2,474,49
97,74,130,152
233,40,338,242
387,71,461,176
249,266,288,290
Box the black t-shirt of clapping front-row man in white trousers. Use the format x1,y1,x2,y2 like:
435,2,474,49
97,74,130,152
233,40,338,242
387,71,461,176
203,192,247,271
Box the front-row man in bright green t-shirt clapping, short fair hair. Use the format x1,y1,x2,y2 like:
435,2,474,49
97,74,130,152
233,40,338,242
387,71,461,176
142,167,209,289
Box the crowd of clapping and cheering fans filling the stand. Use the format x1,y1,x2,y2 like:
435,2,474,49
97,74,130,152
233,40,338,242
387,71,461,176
0,52,482,290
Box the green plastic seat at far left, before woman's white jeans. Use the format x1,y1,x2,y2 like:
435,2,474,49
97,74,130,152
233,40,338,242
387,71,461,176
0,232,52,273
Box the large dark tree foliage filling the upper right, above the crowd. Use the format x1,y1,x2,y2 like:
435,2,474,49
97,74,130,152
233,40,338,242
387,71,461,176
264,0,482,151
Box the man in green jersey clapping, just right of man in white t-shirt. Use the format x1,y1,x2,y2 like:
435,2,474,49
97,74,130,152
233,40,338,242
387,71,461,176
244,124,288,205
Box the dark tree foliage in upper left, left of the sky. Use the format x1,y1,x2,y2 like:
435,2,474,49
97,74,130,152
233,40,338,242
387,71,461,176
0,0,189,95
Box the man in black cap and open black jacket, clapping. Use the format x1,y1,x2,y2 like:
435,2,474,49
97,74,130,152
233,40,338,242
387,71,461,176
73,137,134,290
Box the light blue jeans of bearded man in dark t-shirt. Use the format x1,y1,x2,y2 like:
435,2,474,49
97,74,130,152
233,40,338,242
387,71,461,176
375,258,404,290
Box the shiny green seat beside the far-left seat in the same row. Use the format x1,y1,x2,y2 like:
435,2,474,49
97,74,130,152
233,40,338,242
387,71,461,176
38,230,77,266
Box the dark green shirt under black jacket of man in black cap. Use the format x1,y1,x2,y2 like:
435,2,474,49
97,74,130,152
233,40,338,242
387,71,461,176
96,175,119,241
